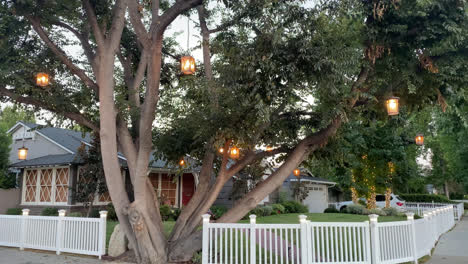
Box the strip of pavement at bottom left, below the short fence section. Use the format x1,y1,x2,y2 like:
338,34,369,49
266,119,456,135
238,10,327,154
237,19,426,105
0,247,130,264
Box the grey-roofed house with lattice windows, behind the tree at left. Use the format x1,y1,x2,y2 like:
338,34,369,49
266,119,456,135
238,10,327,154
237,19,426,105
8,122,197,214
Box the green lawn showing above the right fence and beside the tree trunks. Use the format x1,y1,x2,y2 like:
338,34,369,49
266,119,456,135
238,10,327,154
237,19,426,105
106,213,406,245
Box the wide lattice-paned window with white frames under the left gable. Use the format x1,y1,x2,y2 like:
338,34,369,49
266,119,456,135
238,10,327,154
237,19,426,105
23,168,70,204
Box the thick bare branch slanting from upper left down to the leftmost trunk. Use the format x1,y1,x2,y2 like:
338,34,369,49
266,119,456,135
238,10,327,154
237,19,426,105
26,16,99,93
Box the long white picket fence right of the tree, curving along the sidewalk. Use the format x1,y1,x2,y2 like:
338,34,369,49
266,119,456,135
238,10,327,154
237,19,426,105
202,205,455,264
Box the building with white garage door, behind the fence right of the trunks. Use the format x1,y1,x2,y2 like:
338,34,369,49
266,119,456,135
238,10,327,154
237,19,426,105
215,170,336,213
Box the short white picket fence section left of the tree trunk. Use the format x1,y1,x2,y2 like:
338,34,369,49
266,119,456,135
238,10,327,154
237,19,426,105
0,209,107,258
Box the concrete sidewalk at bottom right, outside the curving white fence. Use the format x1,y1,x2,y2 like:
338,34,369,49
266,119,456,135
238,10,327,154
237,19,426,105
427,216,468,264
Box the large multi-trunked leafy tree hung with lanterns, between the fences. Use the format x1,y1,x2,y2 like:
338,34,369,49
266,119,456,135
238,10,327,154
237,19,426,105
0,0,466,263
